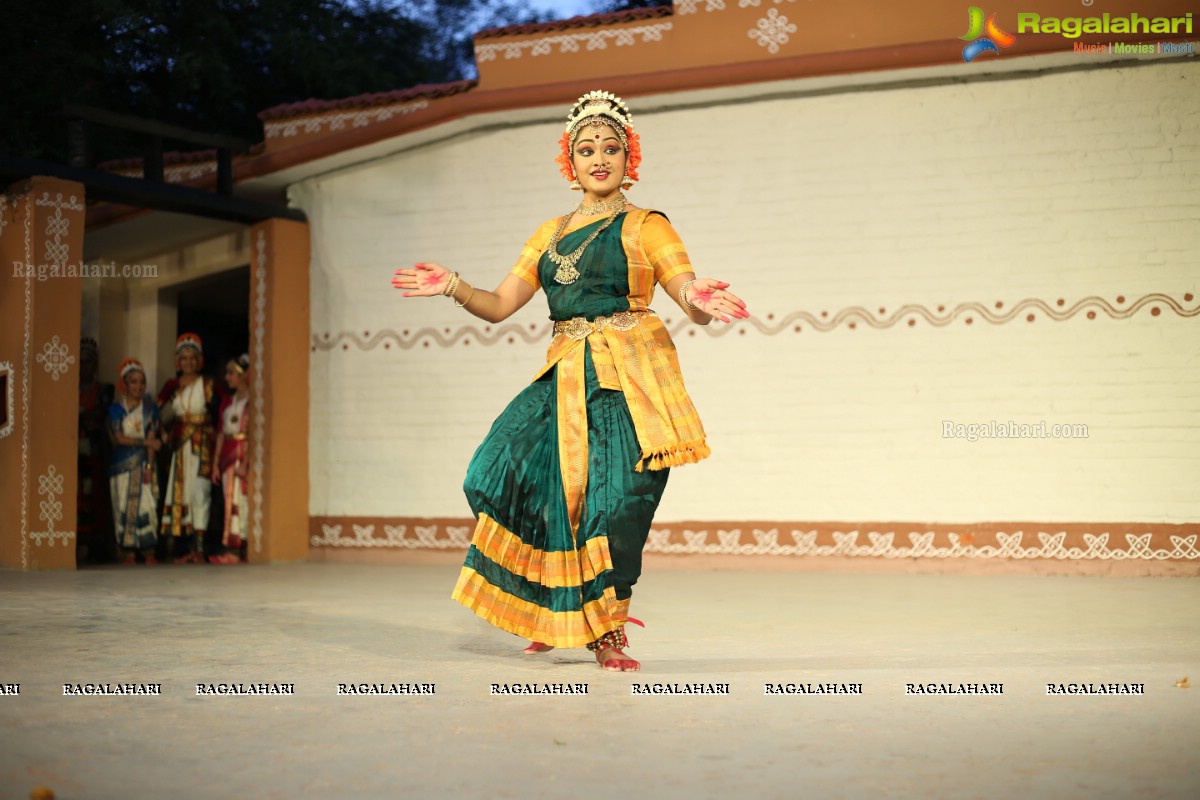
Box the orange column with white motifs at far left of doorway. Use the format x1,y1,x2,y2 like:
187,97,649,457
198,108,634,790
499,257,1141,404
0,178,84,570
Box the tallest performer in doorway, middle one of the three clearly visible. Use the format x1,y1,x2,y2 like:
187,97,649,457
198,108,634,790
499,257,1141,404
158,333,214,564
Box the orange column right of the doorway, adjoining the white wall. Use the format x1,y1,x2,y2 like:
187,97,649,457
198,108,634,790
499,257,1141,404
247,219,311,563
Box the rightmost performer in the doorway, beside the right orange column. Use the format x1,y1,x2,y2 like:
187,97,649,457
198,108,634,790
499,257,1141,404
209,354,250,564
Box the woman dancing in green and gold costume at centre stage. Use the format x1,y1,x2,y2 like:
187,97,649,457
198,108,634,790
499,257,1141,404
392,91,749,672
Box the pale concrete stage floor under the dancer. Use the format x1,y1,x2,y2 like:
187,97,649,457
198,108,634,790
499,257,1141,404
0,564,1200,800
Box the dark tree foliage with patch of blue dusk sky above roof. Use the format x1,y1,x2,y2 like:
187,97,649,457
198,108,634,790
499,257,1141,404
0,0,549,162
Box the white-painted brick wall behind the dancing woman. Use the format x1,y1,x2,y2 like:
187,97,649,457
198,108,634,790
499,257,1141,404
292,61,1200,522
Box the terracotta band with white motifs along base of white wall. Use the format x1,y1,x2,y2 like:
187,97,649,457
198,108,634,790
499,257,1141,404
308,517,1200,561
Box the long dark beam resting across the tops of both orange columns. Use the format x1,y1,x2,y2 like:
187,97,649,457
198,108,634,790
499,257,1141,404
0,155,308,225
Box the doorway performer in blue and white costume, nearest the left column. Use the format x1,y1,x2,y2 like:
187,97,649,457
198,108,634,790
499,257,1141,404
108,359,162,564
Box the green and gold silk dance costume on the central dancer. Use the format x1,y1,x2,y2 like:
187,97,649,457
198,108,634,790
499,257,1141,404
452,209,708,648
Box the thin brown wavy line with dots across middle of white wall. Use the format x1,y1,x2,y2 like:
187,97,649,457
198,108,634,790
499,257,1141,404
312,293,1200,351
